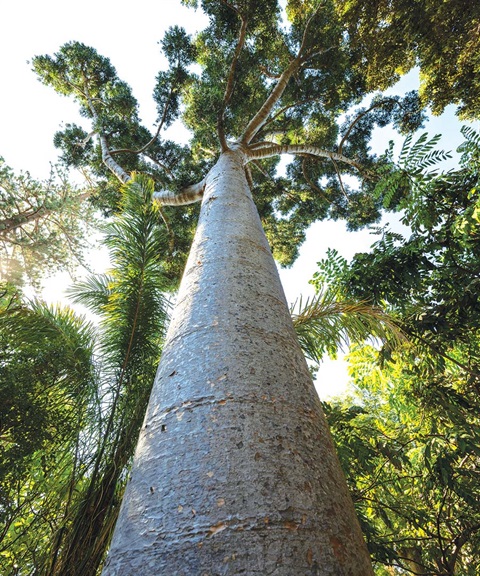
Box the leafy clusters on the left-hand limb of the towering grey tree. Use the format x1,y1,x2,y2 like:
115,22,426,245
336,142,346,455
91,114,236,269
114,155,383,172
33,35,205,289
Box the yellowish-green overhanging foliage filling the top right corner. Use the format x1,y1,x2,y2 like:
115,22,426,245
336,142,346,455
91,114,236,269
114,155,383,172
335,0,480,119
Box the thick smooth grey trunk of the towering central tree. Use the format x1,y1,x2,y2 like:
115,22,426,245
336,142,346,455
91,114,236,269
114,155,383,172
103,150,373,576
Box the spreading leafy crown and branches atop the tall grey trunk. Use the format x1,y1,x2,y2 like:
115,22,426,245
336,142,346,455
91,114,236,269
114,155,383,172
33,2,432,276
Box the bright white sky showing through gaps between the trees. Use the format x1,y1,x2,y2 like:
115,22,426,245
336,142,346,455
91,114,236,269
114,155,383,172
0,0,472,396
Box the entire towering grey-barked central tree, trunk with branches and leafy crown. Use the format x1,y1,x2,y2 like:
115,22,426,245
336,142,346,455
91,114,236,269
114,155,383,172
27,0,480,575
